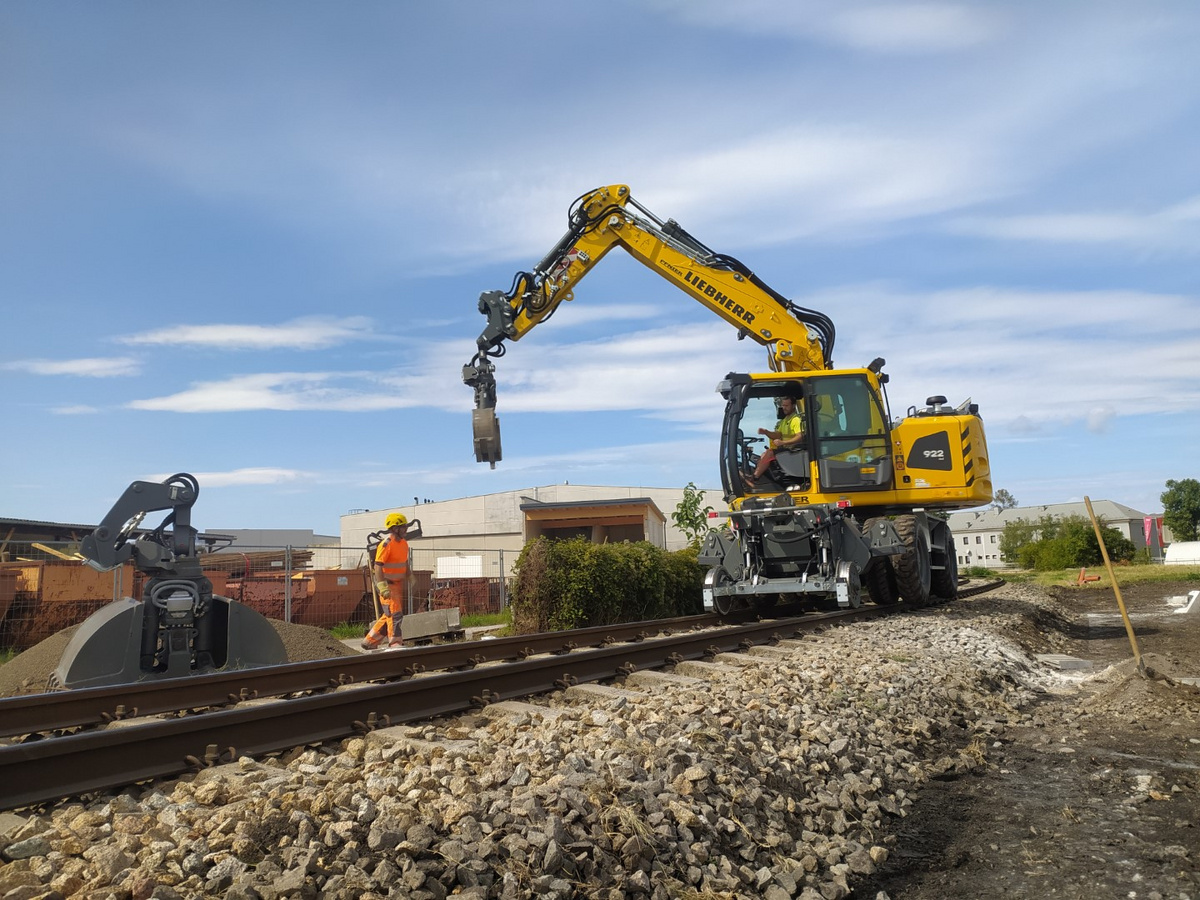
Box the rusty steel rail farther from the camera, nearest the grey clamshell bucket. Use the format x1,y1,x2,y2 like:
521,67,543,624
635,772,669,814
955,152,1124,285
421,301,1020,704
0,614,729,737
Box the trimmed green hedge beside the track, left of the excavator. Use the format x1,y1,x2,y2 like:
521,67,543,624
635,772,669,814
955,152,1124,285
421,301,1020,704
510,538,704,634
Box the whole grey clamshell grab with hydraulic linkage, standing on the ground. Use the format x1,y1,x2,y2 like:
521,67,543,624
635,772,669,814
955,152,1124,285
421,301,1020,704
49,473,288,690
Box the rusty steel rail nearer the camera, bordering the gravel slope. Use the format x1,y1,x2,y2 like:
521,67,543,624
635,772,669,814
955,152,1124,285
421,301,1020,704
0,606,888,809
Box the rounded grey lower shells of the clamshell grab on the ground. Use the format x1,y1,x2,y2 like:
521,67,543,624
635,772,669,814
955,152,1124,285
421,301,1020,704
48,595,288,690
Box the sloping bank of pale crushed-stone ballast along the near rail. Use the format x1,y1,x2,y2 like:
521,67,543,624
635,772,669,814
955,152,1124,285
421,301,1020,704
7,586,1052,900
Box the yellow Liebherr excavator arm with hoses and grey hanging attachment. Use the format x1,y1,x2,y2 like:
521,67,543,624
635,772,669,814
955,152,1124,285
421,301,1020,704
462,185,835,468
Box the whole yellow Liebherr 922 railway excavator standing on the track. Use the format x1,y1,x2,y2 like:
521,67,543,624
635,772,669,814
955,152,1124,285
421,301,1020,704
463,185,992,613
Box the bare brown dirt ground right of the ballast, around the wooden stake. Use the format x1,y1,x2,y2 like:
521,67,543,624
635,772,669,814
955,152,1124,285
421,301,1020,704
854,582,1200,900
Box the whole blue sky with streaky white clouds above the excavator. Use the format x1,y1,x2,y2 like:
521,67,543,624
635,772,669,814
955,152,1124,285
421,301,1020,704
0,0,1200,533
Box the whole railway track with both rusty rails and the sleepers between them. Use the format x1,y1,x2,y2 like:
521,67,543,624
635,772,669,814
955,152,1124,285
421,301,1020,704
0,582,1001,809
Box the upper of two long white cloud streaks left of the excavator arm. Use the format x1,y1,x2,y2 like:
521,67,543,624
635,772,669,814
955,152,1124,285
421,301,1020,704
118,316,376,350
